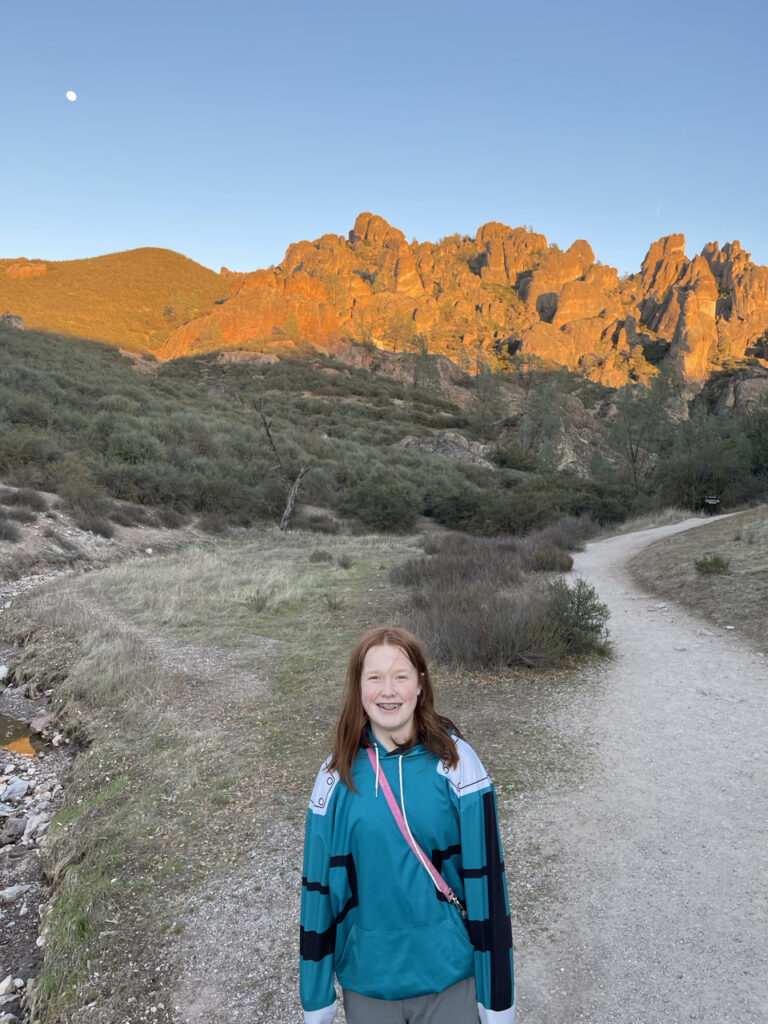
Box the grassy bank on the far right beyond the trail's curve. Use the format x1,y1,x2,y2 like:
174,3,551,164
630,506,768,649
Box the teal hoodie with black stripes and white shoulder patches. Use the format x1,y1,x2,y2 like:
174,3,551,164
300,739,514,1024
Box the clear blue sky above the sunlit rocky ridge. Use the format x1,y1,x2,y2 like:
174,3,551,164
0,0,768,271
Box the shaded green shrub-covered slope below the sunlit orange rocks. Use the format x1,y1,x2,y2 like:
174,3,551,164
0,327,651,557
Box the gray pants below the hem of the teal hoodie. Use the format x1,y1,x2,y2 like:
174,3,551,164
343,978,479,1024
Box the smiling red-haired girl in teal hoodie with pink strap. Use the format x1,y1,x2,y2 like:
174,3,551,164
300,627,515,1024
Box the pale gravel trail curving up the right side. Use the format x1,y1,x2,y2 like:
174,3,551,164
512,520,768,1024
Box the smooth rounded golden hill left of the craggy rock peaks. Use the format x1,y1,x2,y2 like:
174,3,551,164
0,249,228,352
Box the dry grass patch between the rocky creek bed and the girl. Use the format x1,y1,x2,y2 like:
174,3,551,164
3,530,417,1024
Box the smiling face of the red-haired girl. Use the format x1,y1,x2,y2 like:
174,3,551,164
360,643,421,751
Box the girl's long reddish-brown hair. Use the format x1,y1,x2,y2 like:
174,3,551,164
328,626,461,792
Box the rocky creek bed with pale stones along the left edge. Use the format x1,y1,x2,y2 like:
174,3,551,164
0,485,198,1024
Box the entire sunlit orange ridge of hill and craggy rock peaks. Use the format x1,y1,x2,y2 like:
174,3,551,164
0,213,768,385
